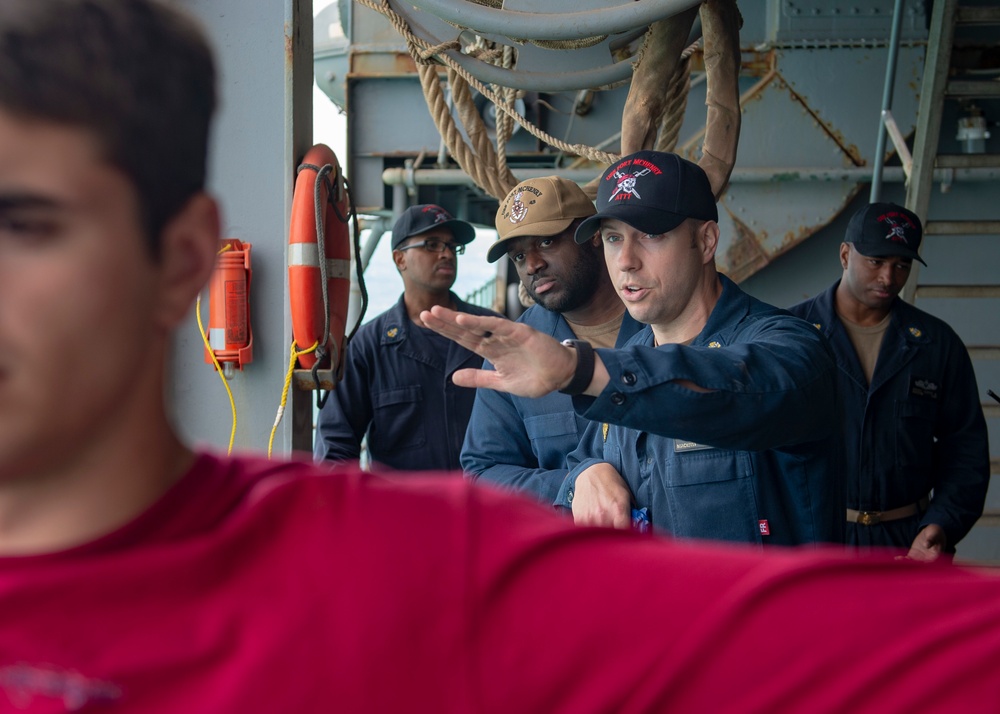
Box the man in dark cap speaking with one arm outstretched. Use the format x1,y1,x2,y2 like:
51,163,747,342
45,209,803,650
422,151,844,545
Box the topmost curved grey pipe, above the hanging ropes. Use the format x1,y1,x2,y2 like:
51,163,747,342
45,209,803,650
402,0,701,40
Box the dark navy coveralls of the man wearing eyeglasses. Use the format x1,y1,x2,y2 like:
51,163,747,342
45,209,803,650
314,293,497,471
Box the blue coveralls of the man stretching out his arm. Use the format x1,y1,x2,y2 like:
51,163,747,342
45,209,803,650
556,276,845,545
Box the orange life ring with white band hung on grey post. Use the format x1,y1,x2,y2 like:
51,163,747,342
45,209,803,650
288,144,351,372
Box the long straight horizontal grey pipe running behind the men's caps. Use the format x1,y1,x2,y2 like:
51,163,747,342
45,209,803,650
382,166,1000,187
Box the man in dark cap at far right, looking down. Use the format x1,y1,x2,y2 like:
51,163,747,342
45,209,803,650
791,203,990,560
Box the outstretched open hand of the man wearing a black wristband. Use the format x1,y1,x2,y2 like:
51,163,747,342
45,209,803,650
420,306,576,397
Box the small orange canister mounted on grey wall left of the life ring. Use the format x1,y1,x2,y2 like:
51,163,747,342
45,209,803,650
205,238,253,379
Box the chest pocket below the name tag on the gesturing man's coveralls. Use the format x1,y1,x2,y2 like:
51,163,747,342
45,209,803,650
666,447,761,543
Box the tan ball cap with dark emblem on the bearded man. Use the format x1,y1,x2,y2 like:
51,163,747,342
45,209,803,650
486,176,597,263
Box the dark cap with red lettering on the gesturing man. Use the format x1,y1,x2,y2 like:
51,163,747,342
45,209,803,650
576,151,719,243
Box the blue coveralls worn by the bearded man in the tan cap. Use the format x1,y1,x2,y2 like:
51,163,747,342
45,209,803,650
462,305,643,504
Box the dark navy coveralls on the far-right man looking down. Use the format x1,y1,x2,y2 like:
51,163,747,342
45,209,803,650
791,281,990,550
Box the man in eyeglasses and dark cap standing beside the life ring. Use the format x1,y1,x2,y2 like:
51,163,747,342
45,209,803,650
315,204,496,471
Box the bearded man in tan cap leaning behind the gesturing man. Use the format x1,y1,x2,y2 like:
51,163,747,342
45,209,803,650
461,176,642,503
